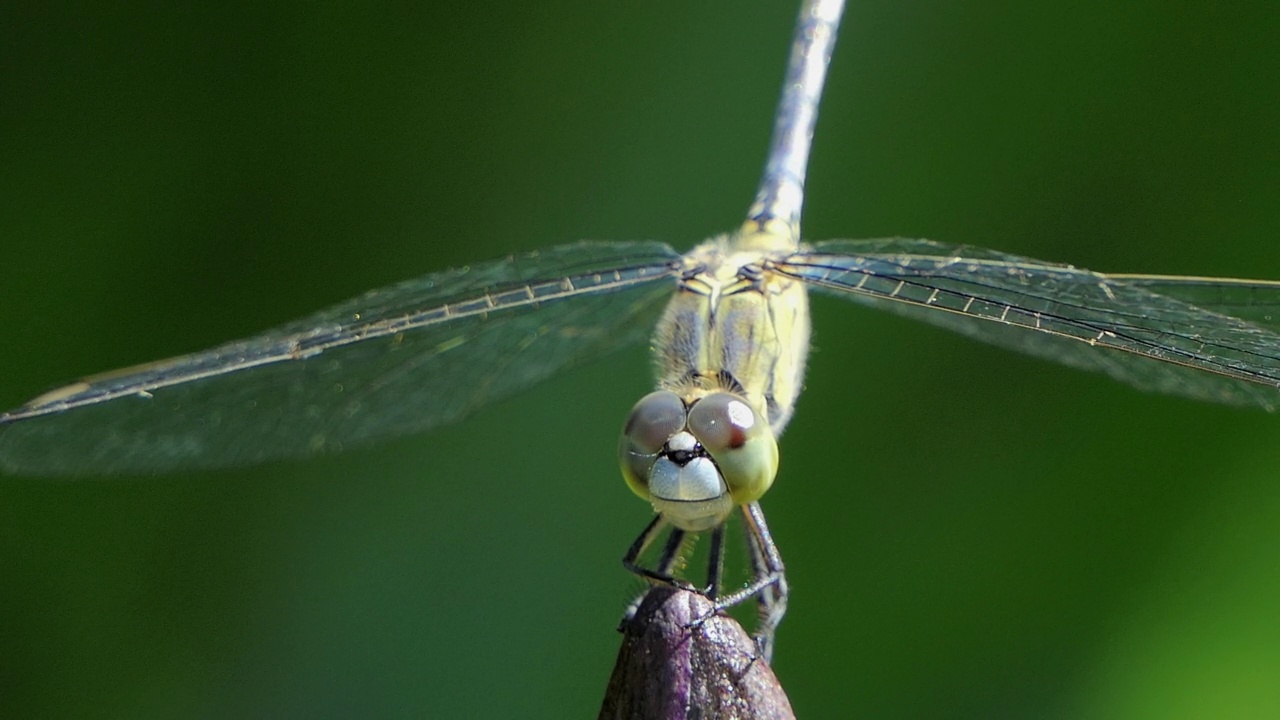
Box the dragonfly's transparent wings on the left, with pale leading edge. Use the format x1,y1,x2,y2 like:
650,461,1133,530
0,242,680,474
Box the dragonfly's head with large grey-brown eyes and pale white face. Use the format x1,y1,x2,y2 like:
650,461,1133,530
618,391,778,532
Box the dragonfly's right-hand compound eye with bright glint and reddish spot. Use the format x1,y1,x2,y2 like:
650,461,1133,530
689,392,778,505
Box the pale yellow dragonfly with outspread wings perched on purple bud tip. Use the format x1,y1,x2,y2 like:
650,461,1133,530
0,0,1280,657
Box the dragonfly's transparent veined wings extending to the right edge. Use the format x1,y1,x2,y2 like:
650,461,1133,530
773,238,1280,410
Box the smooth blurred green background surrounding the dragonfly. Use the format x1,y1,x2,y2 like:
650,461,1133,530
0,0,1280,719
